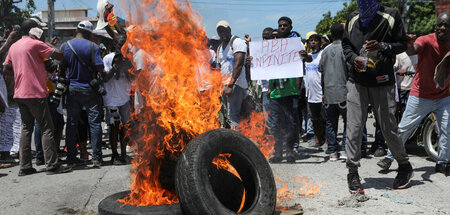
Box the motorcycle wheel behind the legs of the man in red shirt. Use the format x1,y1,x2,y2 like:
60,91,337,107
422,116,439,161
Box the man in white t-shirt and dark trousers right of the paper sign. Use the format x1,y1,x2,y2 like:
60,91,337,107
301,34,325,147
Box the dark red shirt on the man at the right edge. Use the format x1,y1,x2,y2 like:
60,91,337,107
410,33,450,100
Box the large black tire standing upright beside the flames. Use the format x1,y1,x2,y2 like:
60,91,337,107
175,129,276,215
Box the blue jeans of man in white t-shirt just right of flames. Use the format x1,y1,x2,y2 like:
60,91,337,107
222,85,247,127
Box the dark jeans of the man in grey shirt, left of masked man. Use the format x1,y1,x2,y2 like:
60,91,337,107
325,102,347,152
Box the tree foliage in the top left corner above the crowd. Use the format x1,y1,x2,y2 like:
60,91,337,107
0,0,36,32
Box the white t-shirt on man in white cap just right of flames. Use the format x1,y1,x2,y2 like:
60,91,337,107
217,38,248,89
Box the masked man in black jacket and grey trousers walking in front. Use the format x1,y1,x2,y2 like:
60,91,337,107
342,0,413,193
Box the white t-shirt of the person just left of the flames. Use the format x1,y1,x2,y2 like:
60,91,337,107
103,52,131,107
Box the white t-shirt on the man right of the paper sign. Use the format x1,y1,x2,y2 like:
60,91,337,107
303,51,322,103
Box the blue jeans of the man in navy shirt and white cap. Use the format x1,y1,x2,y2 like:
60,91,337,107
66,85,103,162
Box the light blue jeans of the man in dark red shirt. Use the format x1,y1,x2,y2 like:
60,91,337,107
386,95,450,164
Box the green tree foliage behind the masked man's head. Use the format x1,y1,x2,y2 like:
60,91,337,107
316,0,436,36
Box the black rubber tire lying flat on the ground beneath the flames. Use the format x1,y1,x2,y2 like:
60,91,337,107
98,191,183,215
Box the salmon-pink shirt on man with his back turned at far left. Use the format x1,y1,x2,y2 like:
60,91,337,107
4,36,54,99
